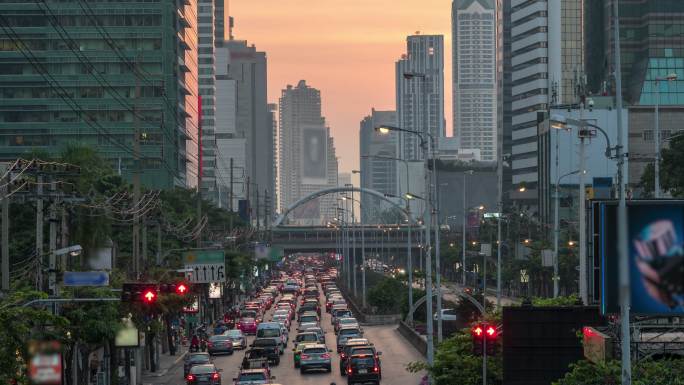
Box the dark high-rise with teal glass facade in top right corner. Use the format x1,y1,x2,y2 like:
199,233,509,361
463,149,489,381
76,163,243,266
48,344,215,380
584,0,684,106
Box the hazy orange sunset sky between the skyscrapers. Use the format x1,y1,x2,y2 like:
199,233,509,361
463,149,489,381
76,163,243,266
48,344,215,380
230,0,451,172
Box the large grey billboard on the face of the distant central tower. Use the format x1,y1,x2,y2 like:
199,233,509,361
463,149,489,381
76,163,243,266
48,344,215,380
300,126,328,185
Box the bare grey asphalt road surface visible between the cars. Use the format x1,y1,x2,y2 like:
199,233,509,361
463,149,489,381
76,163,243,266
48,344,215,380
150,284,424,385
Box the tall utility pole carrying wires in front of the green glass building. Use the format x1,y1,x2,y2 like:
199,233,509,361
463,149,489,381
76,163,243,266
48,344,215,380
132,57,141,279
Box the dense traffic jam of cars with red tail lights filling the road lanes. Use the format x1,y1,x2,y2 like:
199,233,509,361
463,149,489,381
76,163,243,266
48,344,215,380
183,256,382,385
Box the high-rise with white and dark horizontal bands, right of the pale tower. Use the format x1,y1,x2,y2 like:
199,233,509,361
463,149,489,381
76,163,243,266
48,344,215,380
511,0,584,205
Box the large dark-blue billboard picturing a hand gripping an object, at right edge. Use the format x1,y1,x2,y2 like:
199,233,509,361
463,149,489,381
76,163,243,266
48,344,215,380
593,200,684,315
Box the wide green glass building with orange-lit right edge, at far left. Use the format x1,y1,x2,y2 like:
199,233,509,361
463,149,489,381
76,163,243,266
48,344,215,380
0,0,198,188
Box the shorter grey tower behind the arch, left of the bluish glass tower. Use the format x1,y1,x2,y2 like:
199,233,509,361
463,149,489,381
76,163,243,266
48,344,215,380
359,109,400,221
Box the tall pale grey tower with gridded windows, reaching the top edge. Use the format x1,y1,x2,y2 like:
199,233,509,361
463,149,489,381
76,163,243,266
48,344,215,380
451,0,499,161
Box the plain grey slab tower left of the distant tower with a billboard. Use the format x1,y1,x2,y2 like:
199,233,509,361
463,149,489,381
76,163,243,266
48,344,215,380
222,40,275,216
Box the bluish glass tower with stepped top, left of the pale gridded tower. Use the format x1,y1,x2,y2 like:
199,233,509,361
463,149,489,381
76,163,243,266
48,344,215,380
395,35,446,160
